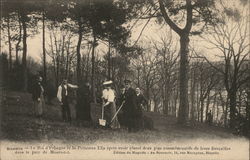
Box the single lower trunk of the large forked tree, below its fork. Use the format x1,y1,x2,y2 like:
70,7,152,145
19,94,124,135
178,34,189,125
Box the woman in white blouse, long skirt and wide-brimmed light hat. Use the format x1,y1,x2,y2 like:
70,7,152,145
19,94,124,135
102,81,120,129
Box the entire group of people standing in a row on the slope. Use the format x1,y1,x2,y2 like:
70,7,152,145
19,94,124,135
32,77,147,132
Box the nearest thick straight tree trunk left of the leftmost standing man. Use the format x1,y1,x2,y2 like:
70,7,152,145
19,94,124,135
21,12,28,92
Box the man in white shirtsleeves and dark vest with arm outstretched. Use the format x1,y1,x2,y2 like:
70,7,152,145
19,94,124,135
57,79,78,122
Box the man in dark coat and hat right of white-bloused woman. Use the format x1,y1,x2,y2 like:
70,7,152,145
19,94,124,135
123,79,138,132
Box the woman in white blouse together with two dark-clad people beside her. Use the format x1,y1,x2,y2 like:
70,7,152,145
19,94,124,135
102,80,147,132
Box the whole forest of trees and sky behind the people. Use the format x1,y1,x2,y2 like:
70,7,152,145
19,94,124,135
0,0,250,136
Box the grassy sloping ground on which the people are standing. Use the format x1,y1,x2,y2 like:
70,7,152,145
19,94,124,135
1,92,242,143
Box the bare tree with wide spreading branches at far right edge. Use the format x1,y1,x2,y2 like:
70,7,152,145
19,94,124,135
203,17,250,128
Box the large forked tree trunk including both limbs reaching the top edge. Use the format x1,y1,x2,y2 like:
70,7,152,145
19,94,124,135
158,0,193,125
